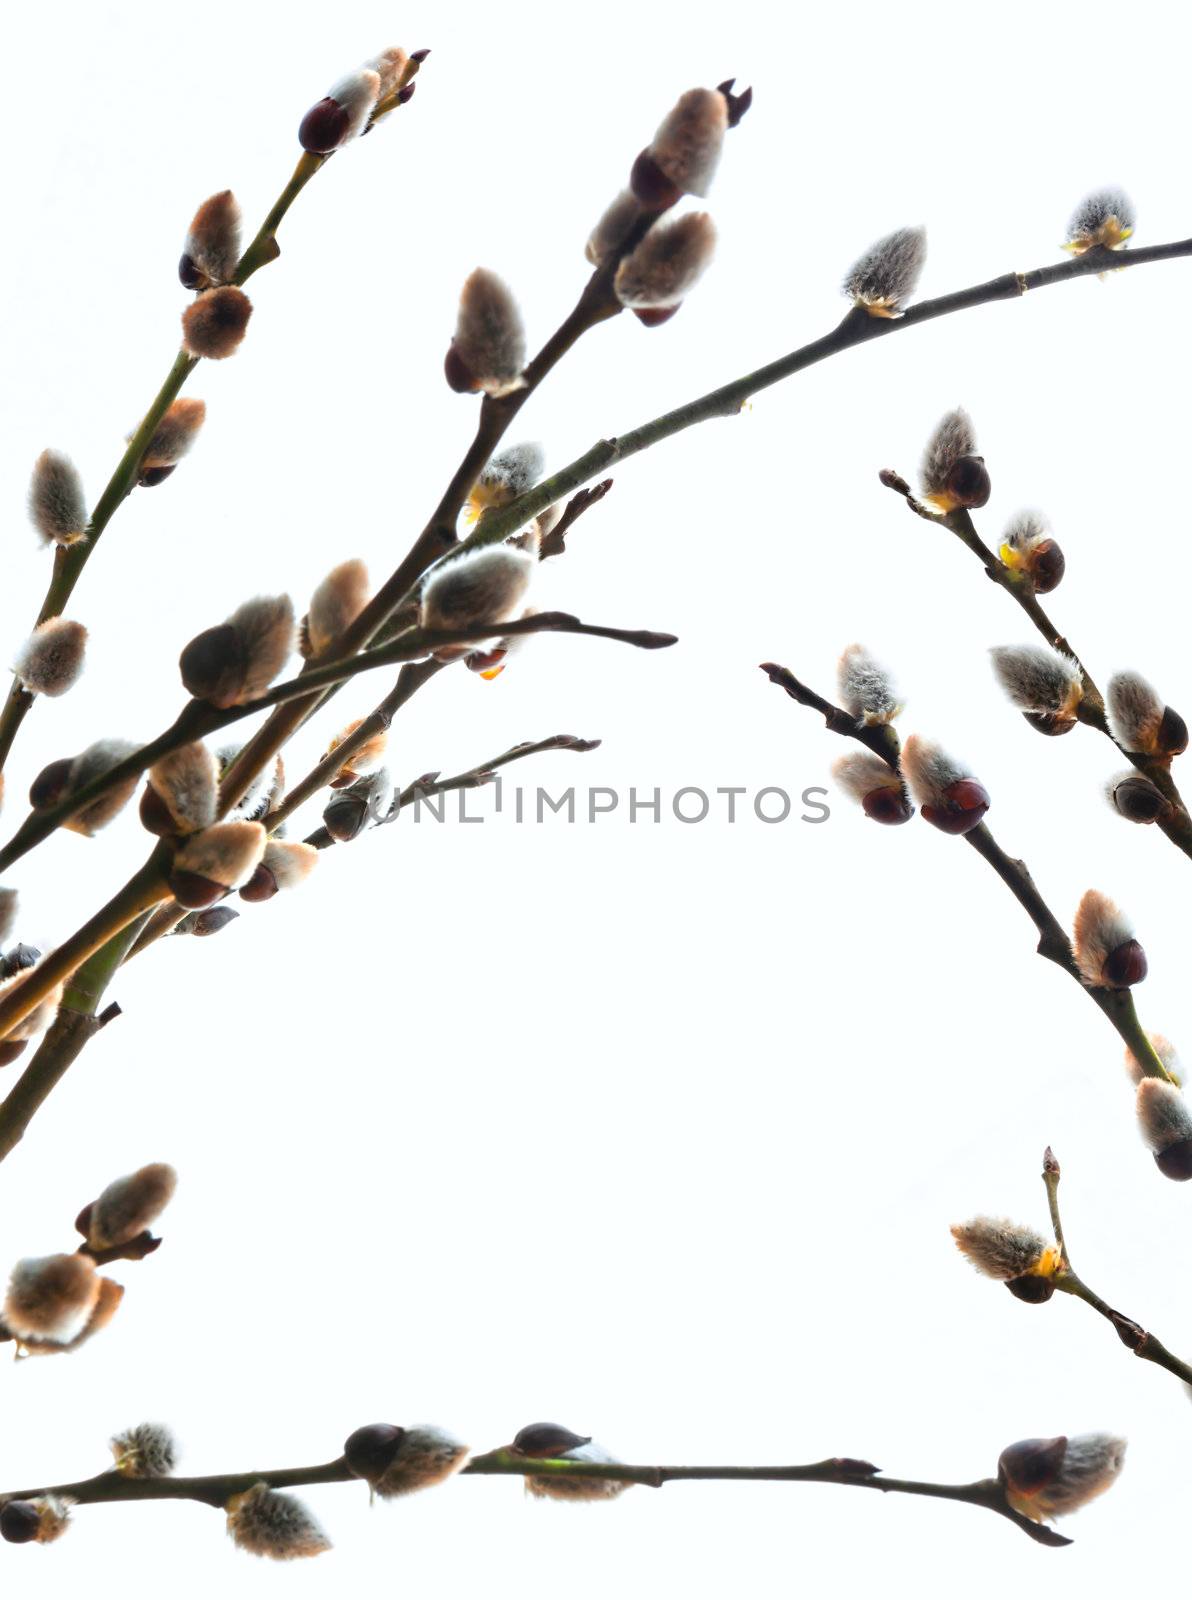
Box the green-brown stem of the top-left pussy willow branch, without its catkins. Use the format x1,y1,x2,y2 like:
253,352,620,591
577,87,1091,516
0,61,419,771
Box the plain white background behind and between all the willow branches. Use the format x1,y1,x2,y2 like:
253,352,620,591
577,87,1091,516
0,0,1192,1597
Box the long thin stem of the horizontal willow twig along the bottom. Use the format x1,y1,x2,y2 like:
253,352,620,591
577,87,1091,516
0,1450,1072,1547
